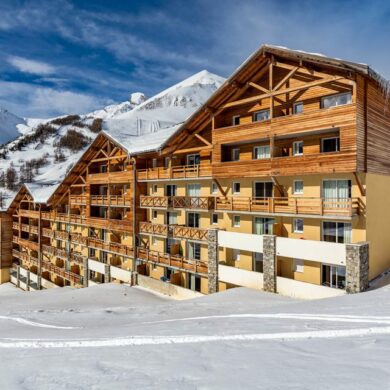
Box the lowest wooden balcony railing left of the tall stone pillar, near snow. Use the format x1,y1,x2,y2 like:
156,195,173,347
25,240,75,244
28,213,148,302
137,247,207,274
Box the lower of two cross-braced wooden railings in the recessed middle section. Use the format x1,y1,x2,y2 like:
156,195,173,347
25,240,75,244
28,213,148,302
139,222,207,241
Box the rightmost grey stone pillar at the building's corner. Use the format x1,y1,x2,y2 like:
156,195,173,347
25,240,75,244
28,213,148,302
345,242,369,294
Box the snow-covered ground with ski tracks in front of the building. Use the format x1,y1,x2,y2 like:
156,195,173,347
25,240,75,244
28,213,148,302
0,284,390,390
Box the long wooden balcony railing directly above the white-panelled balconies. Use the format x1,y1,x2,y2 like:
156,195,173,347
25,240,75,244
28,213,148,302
215,196,360,217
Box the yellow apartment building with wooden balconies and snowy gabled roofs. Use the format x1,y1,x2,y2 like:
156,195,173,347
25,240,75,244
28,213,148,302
4,46,390,293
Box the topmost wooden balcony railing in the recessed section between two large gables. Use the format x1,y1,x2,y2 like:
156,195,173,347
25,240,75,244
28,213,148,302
137,165,211,181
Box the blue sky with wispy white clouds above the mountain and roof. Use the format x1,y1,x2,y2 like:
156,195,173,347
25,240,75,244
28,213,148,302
0,0,390,117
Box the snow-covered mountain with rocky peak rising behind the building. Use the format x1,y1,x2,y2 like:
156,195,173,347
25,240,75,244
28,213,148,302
0,70,225,207
